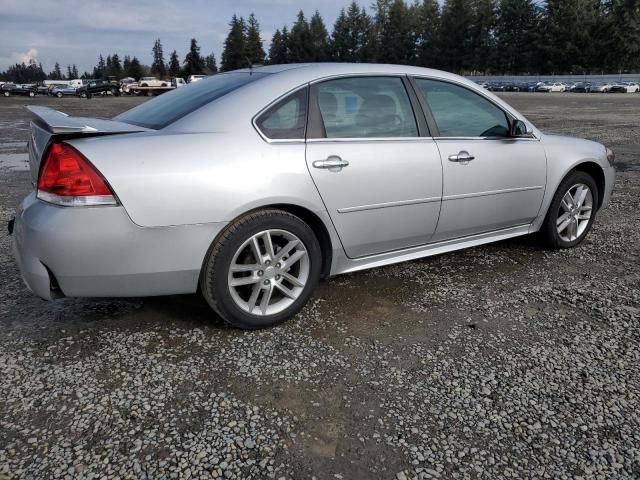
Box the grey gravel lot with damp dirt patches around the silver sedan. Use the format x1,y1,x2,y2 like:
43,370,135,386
0,93,640,480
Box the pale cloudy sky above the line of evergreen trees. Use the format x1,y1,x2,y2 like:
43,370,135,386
0,0,370,72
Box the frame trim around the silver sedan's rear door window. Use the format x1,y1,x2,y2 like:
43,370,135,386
306,73,430,142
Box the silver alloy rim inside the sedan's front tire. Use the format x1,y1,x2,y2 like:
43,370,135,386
556,183,593,242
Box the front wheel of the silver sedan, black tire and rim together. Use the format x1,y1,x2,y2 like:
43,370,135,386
540,171,599,249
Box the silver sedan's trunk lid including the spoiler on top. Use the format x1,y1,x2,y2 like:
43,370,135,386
27,106,149,183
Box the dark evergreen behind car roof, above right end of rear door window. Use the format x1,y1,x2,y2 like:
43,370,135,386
378,0,416,65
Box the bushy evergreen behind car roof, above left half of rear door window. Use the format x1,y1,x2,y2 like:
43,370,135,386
331,0,374,62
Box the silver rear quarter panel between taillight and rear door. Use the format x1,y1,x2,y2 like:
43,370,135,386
70,126,324,227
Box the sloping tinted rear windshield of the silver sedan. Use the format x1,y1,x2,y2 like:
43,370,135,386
114,72,267,130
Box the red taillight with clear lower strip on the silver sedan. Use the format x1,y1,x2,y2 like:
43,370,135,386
38,143,116,205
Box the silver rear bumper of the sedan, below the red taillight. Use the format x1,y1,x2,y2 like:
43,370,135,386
13,193,225,299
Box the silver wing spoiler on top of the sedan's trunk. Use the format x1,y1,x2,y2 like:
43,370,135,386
27,105,149,135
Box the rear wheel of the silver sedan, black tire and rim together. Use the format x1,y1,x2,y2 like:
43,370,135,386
200,209,322,330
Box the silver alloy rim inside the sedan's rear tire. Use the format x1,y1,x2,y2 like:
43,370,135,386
227,229,311,316
